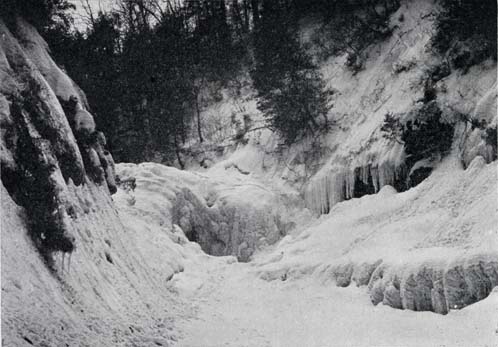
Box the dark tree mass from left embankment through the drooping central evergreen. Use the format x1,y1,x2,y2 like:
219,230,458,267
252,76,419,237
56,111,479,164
4,0,342,166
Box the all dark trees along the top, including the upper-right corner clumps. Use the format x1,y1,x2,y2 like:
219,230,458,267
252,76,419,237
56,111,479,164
0,0,496,166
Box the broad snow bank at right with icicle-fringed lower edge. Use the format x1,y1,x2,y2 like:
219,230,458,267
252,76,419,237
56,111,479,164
256,157,498,313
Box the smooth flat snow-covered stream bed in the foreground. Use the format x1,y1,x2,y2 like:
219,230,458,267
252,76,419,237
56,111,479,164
172,253,498,347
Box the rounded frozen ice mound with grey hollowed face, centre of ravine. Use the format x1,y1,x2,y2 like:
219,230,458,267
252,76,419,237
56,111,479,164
117,163,310,261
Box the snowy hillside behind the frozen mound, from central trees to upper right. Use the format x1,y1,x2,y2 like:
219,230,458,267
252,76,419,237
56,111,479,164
189,0,497,214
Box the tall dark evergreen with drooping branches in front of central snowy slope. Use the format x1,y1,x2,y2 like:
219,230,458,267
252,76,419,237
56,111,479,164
252,0,328,144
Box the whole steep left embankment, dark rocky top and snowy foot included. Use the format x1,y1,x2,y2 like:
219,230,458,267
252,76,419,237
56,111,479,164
0,19,189,346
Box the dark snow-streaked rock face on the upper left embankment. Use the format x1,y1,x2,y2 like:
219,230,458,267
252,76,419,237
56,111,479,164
0,19,116,254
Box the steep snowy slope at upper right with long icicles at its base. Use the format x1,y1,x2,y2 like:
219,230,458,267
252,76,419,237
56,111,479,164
305,0,496,212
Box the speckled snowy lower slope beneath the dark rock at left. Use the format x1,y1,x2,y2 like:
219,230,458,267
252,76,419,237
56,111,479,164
1,181,189,346
